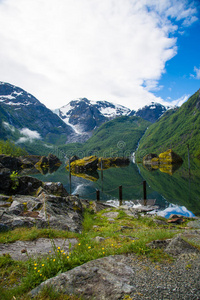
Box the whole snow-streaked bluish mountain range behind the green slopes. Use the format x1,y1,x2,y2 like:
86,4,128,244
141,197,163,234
0,82,170,144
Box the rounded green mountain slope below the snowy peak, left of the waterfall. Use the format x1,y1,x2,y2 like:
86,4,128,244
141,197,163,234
83,116,150,157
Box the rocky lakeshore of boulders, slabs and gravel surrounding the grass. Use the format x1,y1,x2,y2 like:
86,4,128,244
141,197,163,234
0,162,200,300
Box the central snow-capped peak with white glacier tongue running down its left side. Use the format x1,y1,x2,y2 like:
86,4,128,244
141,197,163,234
54,98,131,141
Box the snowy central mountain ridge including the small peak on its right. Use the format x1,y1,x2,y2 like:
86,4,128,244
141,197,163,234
54,98,167,142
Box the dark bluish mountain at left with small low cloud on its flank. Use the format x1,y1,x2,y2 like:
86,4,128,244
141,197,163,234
0,82,73,143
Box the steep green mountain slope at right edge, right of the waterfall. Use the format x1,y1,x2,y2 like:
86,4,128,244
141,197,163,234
137,90,200,160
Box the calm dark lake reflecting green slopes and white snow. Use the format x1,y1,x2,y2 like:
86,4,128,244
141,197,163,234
31,160,200,217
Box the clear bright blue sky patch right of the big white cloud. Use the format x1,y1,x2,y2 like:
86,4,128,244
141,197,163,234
155,7,200,105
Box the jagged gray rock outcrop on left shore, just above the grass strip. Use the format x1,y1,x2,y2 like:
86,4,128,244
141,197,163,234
0,190,83,232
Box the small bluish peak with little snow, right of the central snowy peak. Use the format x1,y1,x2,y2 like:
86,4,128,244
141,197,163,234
134,102,169,123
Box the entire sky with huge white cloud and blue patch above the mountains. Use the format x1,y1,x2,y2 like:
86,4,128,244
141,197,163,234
0,0,200,110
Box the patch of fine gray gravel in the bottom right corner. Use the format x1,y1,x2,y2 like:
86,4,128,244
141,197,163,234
126,253,200,300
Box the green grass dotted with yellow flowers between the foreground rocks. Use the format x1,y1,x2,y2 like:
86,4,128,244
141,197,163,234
0,208,190,300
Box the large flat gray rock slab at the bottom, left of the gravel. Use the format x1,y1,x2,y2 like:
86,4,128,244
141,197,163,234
30,255,135,300
